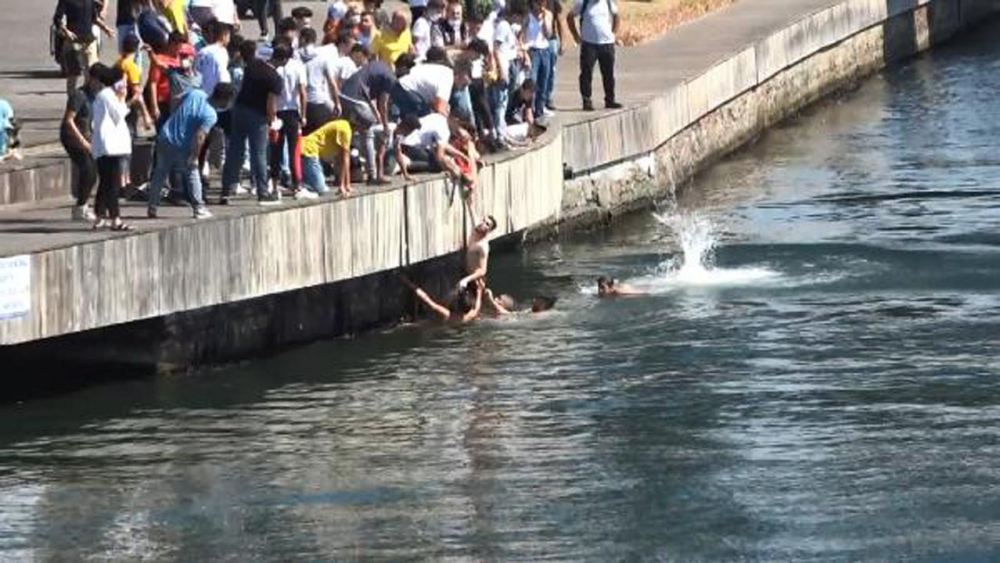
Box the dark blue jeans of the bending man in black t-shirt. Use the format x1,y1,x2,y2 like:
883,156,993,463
222,105,268,197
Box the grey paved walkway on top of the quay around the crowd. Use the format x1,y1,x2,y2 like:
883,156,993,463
0,0,837,256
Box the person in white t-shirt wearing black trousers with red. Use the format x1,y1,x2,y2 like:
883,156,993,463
270,38,307,192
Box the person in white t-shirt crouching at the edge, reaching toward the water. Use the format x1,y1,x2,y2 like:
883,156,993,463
396,112,467,182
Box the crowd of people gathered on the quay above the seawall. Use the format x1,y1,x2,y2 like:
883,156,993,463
53,0,620,230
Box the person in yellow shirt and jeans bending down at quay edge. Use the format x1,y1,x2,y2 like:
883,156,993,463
296,119,352,198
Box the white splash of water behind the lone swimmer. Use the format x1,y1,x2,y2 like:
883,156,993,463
635,213,780,292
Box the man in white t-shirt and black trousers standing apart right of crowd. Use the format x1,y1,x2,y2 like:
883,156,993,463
566,0,622,111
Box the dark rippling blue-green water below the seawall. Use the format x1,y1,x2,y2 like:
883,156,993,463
0,27,1000,561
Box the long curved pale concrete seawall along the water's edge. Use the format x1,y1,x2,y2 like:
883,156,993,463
0,0,1000,376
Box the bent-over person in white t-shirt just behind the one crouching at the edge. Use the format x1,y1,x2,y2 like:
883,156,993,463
392,47,455,116
